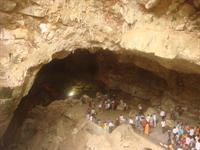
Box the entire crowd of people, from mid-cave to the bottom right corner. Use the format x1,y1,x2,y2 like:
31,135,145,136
82,94,200,150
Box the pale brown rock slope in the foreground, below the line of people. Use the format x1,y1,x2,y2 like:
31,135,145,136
5,101,162,150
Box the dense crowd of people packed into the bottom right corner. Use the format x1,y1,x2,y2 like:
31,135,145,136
164,122,200,150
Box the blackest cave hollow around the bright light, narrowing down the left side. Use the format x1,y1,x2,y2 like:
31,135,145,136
1,49,109,149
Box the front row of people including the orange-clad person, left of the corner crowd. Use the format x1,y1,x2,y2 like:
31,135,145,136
86,104,166,135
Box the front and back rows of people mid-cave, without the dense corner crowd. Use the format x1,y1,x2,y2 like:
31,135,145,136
81,93,161,135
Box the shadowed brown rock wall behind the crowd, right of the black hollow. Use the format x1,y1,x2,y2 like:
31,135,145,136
96,51,200,103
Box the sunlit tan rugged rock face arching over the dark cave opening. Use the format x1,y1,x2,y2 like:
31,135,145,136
0,0,200,136
